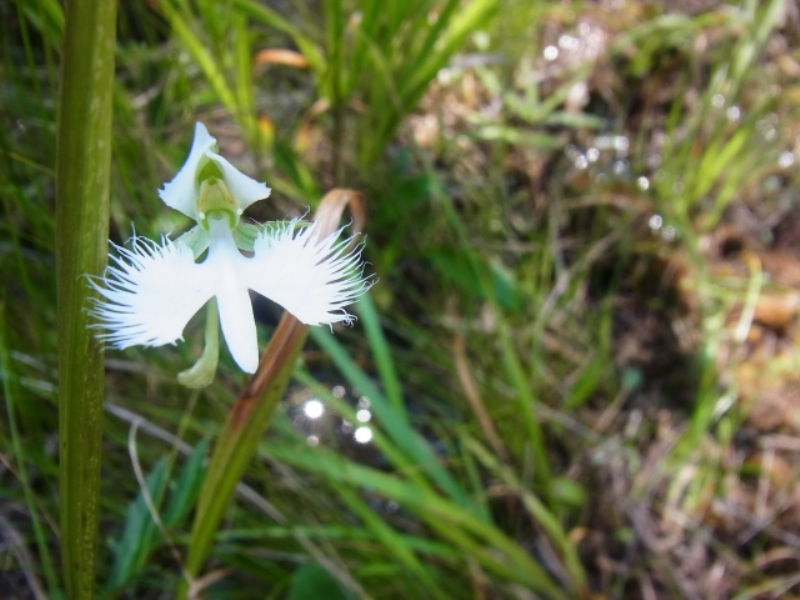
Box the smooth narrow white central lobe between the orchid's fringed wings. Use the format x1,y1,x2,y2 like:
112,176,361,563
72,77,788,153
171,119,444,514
203,219,258,373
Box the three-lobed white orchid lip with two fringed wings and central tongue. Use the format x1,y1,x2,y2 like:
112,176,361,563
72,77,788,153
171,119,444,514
90,218,372,373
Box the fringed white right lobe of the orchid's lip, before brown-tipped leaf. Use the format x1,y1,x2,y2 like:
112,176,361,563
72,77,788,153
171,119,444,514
241,220,372,325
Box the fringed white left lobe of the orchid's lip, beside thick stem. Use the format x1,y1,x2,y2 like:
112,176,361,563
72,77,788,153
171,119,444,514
90,237,213,349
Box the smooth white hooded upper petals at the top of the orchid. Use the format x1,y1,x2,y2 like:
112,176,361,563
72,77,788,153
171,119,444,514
158,122,272,222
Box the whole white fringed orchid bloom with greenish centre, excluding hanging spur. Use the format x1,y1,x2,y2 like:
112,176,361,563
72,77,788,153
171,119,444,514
90,123,371,380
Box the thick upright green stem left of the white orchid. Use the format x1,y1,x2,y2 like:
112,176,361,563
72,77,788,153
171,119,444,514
56,0,116,600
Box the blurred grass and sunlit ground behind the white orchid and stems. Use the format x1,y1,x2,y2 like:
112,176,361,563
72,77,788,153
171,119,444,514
0,0,800,600
